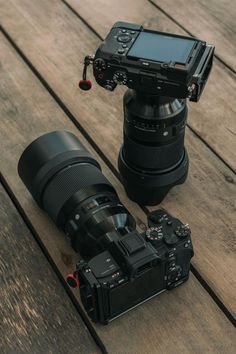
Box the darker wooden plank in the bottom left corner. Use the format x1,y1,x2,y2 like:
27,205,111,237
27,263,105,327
0,184,100,354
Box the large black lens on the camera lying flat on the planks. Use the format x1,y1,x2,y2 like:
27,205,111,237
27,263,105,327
18,131,135,256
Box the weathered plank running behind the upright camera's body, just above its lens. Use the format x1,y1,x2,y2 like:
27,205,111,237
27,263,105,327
67,0,236,170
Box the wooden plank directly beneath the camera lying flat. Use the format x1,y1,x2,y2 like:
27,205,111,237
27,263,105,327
0,33,236,354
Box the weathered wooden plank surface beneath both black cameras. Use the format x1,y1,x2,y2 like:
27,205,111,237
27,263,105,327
0,0,236,354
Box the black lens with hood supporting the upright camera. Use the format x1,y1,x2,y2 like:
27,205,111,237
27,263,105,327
118,90,188,205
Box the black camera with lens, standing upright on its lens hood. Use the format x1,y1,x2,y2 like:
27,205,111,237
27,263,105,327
79,22,214,205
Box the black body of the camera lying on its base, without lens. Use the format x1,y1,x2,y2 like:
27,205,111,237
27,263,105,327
74,209,193,324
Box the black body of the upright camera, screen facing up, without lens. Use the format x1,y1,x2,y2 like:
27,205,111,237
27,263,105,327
93,22,214,102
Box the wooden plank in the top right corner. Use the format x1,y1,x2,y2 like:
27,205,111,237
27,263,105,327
150,0,236,70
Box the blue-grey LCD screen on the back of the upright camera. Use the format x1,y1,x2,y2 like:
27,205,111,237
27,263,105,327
128,32,196,64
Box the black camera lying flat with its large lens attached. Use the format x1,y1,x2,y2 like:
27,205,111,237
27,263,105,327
18,131,193,324
